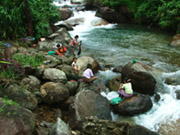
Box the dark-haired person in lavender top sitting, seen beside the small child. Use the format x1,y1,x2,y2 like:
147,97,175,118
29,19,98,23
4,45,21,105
83,64,97,83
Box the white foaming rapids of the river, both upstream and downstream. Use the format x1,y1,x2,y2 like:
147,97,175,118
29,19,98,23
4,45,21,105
54,0,180,131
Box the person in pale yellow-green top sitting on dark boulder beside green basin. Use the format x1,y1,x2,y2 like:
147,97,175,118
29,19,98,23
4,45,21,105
118,78,133,99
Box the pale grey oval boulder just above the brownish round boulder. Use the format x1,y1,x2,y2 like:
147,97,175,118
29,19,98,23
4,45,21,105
43,68,67,83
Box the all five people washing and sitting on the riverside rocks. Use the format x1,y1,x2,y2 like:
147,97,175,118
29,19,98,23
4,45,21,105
56,35,133,99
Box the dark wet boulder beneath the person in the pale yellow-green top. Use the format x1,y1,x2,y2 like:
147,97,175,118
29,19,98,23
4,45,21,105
113,95,152,116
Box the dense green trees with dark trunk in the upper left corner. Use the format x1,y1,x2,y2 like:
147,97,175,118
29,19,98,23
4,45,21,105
0,0,60,39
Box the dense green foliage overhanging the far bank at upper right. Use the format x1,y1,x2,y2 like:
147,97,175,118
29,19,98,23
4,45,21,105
87,0,180,32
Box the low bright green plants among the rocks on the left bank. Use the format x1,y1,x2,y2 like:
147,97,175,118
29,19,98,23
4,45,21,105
13,54,45,67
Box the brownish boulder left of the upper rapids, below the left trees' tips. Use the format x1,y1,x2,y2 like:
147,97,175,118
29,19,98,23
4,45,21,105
59,8,73,20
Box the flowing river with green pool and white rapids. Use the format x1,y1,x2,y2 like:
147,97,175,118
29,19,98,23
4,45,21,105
54,0,180,131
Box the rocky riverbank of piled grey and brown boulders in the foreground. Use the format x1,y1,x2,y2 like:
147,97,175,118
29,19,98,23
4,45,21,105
0,28,163,135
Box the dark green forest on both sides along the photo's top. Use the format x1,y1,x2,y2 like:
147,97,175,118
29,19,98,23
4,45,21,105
0,0,180,40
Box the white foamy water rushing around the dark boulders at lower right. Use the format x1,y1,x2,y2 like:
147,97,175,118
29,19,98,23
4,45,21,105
101,71,180,131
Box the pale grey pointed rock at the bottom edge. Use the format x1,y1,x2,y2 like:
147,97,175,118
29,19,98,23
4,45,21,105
49,118,71,135
